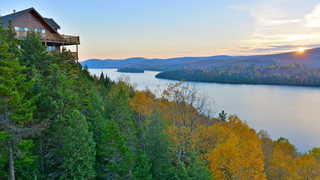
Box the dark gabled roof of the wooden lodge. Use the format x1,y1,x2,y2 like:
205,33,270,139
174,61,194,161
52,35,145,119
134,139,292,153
0,8,60,32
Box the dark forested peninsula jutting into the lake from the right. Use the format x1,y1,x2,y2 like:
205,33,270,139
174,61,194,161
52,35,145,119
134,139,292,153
156,64,320,86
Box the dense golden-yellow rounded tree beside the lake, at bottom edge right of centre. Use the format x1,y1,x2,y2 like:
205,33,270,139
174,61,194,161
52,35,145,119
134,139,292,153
207,116,266,180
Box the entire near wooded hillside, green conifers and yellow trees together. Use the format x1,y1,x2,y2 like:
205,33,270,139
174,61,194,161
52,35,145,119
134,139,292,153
0,29,320,180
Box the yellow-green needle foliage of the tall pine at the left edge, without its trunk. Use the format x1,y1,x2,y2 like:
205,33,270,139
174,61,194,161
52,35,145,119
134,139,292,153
0,28,34,125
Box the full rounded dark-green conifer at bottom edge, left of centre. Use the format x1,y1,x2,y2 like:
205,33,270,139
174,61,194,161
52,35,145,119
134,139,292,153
54,110,95,179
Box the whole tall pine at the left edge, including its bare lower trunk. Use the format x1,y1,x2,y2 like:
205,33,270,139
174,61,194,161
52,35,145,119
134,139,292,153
0,28,46,179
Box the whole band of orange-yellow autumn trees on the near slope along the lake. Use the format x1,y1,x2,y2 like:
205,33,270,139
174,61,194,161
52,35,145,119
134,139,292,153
129,84,320,180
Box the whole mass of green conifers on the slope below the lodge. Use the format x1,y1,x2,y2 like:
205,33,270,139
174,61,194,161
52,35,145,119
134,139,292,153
0,25,214,180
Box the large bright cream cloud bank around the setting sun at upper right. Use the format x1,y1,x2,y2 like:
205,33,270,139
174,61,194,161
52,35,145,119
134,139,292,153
231,0,320,53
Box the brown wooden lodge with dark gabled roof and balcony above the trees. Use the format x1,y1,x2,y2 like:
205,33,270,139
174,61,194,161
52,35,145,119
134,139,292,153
0,8,80,60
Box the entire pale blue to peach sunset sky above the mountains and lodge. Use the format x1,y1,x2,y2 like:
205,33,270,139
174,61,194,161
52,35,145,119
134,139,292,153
0,0,320,60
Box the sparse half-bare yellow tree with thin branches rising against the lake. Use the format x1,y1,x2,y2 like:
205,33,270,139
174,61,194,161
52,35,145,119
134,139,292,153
159,83,209,159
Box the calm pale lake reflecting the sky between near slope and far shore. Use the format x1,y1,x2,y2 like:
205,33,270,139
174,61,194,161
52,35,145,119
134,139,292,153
89,69,320,152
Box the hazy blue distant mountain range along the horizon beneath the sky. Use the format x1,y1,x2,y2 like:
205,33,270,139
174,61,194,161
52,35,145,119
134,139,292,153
81,48,320,71
